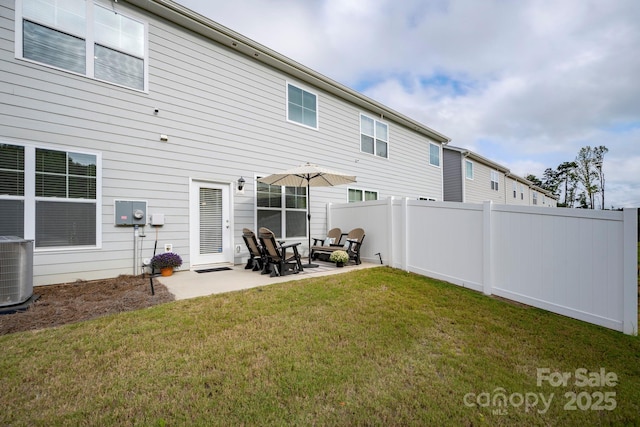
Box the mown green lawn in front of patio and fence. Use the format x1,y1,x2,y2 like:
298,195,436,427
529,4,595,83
0,267,640,426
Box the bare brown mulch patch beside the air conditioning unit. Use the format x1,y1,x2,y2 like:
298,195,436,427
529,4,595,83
0,276,174,335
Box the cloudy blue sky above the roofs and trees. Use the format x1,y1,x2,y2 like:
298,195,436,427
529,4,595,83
177,0,640,208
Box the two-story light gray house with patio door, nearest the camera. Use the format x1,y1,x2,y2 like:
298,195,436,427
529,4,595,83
0,0,449,285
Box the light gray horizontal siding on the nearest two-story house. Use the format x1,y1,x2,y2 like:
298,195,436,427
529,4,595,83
0,2,443,285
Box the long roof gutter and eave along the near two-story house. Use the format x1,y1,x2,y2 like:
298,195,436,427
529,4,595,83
124,0,451,144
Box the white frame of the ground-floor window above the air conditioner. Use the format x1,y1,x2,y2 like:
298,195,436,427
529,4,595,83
0,140,102,252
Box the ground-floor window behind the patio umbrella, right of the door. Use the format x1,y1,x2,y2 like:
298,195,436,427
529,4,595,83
256,182,307,238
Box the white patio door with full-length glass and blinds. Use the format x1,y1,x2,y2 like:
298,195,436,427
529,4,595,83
190,181,233,266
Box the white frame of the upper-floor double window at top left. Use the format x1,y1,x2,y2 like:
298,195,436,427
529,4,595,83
14,0,149,93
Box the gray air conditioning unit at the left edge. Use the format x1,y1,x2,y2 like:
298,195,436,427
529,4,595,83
0,236,33,307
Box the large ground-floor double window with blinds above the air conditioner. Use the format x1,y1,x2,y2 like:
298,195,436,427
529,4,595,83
0,144,100,248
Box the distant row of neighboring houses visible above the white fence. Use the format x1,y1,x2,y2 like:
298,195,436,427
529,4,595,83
442,145,558,207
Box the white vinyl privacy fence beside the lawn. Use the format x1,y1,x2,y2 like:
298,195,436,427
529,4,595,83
327,198,638,335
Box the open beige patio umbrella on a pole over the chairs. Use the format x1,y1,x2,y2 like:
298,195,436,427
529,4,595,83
258,162,356,267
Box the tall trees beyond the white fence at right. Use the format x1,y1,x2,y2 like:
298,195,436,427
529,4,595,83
526,145,609,209
